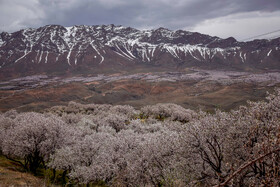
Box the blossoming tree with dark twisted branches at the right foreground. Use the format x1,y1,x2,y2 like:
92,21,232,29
183,90,280,186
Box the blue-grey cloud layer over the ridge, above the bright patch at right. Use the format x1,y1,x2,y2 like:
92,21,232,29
0,0,280,39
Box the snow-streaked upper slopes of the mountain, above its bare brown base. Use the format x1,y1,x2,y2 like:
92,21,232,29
0,25,279,66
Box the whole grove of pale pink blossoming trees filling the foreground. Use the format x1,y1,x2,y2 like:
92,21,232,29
0,89,280,186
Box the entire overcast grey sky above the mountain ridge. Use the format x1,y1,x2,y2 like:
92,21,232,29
0,0,280,40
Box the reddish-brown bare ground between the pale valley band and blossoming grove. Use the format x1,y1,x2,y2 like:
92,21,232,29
0,80,273,112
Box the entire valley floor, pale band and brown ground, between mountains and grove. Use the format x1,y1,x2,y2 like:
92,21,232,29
0,69,280,112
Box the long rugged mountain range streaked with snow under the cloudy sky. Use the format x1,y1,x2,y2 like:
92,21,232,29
0,25,280,78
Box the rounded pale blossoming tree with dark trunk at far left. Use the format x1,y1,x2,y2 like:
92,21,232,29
1,112,69,174
